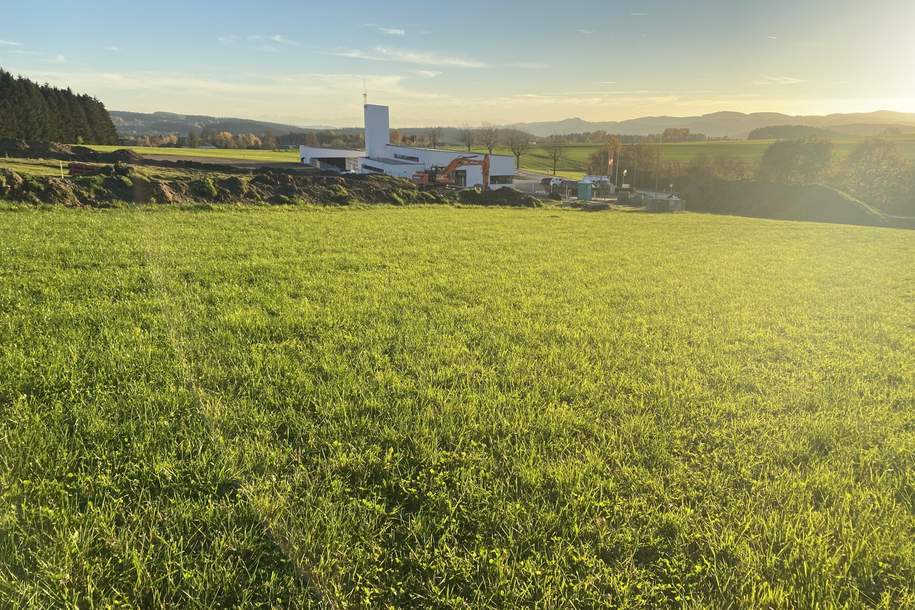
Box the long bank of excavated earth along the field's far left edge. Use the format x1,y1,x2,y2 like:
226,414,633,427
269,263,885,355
0,140,540,207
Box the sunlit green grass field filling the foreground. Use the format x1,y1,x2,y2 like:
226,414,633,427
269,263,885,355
0,208,915,609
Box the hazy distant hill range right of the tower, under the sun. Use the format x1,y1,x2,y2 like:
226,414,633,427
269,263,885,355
511,111,915,139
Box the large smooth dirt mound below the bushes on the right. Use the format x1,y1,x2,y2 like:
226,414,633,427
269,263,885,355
682,180,888,226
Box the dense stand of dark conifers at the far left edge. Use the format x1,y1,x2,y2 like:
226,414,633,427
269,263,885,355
0,69,118,144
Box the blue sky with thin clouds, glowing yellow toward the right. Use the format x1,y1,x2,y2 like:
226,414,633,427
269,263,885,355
0,0,915,125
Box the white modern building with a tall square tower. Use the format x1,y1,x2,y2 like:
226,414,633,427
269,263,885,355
299,104,515,189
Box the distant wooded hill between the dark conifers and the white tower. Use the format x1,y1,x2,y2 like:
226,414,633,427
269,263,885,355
109,110,331,136
